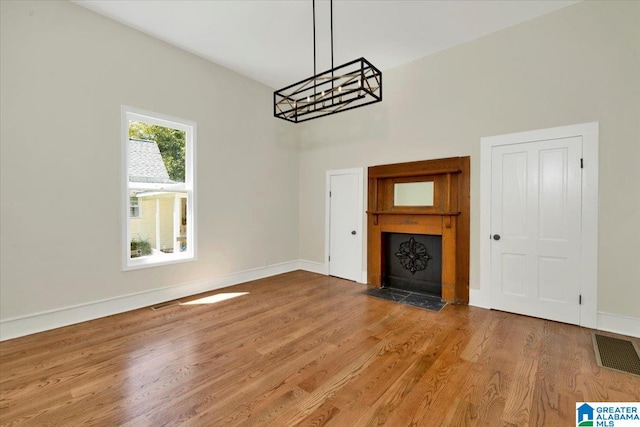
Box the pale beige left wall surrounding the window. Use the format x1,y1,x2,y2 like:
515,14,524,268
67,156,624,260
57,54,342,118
0,1,298,328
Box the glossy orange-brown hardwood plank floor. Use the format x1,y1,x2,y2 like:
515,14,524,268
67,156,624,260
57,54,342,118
0,271,640,427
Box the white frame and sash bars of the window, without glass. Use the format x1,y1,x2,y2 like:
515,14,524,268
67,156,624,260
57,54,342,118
120,105,197,271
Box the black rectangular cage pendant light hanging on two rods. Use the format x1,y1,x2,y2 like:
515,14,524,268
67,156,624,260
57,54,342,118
273,0,382,123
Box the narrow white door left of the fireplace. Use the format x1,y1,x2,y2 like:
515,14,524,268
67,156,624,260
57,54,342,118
329,173,362,281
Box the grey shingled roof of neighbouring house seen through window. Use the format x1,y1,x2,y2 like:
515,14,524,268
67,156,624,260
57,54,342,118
129,139,174,184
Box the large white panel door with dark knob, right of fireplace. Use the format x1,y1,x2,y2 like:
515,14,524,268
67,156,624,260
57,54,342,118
490,137,582,324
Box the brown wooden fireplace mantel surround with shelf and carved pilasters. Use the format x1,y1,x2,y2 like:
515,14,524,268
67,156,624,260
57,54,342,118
367,156,470,303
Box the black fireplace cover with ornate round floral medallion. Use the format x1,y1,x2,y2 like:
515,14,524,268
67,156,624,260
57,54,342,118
382,233,442,298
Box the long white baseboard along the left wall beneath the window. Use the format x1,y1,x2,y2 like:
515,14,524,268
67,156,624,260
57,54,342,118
0,260,302,341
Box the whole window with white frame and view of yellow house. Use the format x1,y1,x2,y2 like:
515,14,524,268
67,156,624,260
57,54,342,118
122,106,196,270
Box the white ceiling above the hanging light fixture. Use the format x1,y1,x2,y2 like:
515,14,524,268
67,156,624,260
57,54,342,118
74,0,577,89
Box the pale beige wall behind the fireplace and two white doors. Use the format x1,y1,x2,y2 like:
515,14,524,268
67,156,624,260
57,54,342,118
299,1,640,319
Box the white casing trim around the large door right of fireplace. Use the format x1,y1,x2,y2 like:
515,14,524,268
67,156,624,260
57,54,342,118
480,122,599,328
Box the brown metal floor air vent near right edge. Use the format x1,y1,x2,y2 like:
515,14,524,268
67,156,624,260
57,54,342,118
592,334,640,376
